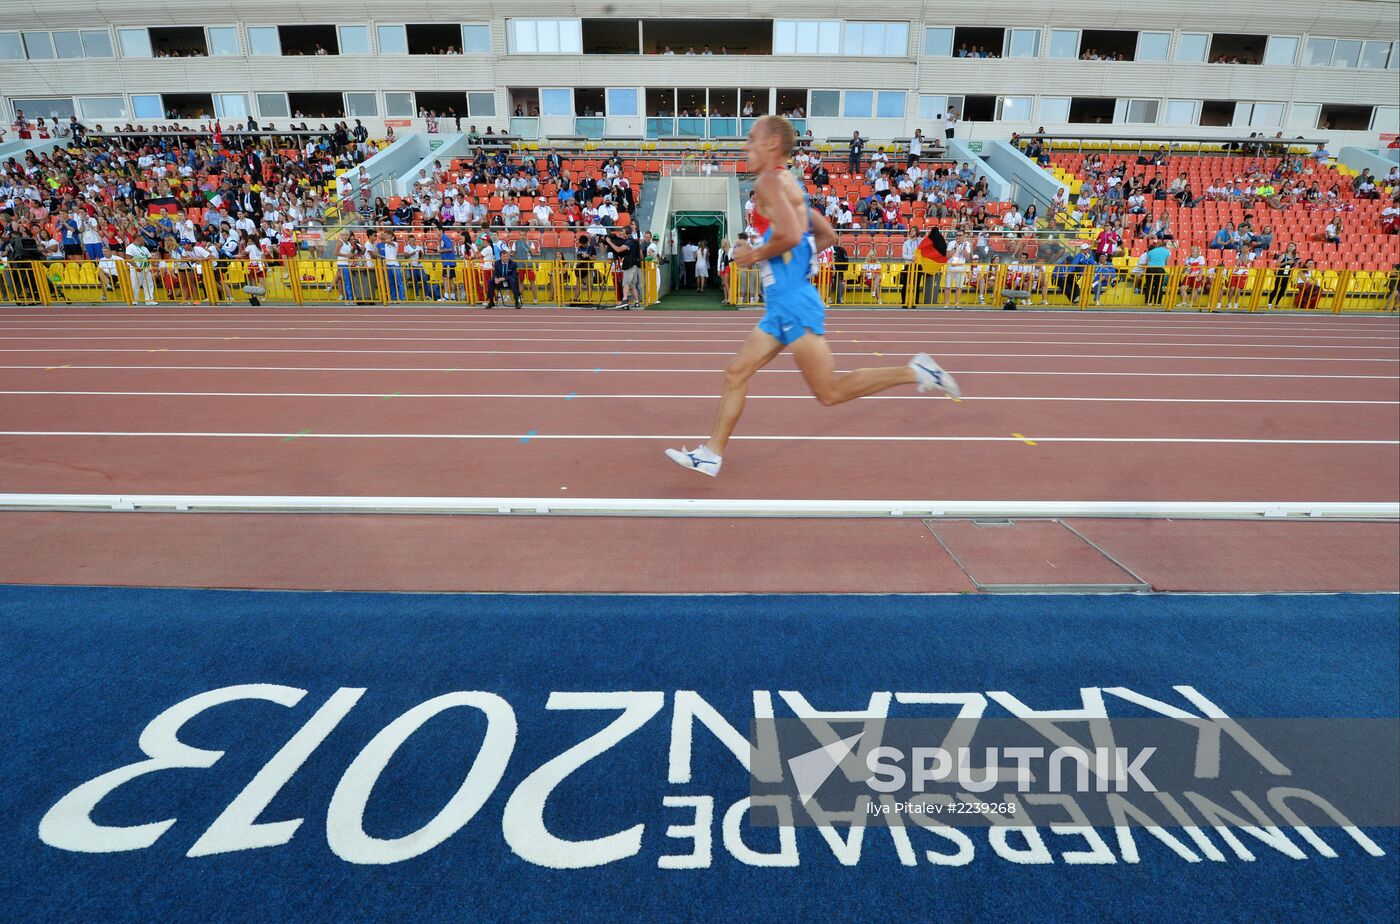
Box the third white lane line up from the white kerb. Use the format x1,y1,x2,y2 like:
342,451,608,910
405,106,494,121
0,364,1400,381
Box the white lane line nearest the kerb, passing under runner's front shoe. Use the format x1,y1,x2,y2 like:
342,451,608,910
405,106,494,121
0,430,1400,447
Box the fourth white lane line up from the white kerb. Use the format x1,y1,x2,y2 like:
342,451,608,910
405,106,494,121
0,347,1400,363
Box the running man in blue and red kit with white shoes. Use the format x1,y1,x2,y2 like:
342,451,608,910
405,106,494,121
666,115,962,477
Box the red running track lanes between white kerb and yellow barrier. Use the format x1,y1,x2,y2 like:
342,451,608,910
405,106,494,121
0,308,1400,501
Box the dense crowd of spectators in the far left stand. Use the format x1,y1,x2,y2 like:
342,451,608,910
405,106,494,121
0,115,375,301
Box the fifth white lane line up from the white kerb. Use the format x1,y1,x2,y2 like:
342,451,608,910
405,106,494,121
0,335,1400,353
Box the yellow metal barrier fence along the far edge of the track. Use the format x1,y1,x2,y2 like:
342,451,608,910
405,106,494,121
0,258,1400,314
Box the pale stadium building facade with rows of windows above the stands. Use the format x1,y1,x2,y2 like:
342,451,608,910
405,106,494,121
0,0,1400,147
